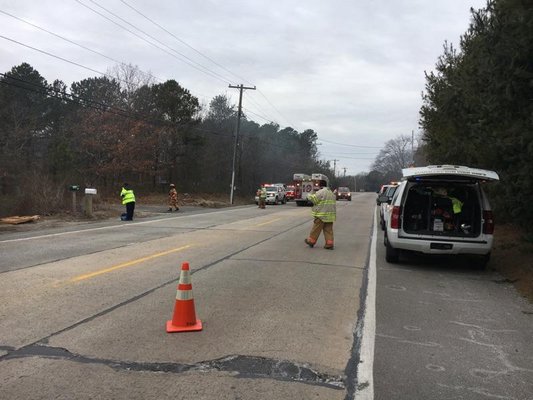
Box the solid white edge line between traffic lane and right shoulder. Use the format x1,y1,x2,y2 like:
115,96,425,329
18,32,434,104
355,213,378,400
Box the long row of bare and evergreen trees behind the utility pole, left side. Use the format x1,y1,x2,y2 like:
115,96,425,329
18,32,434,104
0,63,332,213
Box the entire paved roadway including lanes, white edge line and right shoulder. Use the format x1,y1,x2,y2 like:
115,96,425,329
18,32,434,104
0,193,533,400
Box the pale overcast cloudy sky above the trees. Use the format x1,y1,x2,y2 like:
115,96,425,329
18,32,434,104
0,0,486,175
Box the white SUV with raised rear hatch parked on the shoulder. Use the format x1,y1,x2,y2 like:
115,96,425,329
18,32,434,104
384,165,499,267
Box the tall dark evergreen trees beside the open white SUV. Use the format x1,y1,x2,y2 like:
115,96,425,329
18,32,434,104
420,0,533,231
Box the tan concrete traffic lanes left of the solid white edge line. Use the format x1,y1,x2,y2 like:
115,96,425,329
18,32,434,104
0,193,375,400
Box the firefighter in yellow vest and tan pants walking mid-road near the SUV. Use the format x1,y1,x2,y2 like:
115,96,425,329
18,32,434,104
305,181,337,250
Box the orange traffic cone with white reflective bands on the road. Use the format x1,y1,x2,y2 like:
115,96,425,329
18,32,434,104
167,262,202,333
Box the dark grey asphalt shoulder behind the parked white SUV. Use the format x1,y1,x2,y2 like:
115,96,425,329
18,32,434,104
374,223,533,400
